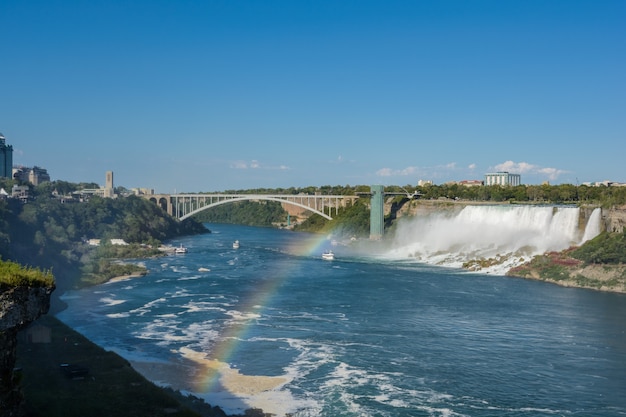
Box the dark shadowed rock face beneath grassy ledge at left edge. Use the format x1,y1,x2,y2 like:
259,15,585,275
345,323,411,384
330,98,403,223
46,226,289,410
0,287,54,417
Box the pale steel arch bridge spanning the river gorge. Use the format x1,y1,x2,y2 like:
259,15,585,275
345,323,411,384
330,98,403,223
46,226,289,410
143,194,359,220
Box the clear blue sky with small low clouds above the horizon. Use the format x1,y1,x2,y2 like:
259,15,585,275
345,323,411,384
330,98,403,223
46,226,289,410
0,0,626,193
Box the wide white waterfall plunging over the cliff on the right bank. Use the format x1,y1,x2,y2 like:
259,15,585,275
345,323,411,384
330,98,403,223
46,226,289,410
387,206,600,274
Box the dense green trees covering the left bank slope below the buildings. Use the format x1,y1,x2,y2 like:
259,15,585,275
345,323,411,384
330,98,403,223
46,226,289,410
0,179,207,290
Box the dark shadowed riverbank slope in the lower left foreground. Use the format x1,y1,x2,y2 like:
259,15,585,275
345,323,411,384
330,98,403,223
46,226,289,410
16,315,233,417
